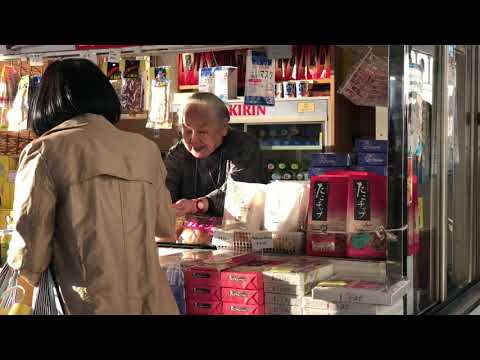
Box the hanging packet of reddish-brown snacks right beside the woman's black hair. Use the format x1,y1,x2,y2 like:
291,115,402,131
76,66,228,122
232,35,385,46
120,60,144,113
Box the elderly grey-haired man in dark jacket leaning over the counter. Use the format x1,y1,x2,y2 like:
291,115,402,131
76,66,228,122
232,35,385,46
165,93,265,216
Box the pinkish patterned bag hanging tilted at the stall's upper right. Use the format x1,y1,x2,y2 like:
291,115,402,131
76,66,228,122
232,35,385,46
338,48,388,106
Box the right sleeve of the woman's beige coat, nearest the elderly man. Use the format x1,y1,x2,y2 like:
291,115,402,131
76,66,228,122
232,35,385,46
155,158,175,239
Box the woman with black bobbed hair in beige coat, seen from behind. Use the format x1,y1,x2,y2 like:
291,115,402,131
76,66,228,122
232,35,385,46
7,59,178,314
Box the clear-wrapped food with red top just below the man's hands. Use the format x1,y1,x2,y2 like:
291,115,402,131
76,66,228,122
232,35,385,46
179,216,221,244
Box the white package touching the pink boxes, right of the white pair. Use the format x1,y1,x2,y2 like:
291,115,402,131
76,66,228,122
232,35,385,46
264,181,308,232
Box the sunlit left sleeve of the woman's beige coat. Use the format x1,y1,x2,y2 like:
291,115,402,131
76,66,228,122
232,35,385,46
7,151,57,285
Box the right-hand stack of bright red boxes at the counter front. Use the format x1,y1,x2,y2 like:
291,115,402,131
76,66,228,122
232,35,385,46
221,259,281,315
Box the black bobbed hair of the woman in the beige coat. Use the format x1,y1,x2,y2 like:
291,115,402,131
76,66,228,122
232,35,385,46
28,59,121,136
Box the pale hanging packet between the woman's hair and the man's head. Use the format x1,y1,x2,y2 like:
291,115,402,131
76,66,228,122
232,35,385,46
146,66,173,129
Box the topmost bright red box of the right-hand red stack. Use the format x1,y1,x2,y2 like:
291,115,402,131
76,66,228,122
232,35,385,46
220,260,281,290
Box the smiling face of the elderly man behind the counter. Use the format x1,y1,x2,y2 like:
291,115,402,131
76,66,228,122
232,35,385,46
182,104,228,159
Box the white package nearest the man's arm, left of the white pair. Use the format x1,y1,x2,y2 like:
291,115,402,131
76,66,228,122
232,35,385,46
223,179,265,232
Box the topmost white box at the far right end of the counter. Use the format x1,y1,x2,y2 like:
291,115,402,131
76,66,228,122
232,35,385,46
312,277,410,305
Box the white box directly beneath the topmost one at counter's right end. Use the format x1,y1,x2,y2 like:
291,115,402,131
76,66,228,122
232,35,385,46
302,296,403,315
